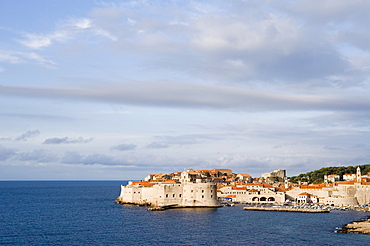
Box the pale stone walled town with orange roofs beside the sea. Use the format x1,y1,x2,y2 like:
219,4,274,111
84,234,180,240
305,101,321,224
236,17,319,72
116,167,370,208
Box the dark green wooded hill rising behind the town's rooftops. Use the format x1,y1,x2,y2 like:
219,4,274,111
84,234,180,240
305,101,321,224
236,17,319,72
289,164,370,184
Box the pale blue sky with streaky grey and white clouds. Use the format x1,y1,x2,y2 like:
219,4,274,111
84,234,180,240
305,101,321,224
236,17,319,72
0,0,370,180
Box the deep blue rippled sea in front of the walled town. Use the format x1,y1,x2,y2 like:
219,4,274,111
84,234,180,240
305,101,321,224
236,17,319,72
0,181,370,245
